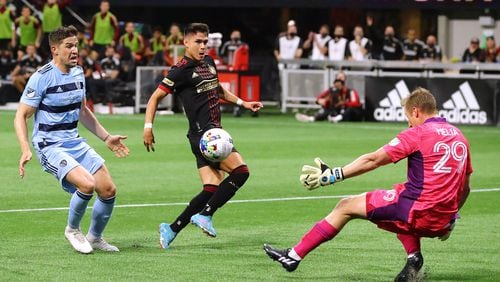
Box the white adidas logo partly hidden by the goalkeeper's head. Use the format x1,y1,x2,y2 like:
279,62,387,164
373,80,410,121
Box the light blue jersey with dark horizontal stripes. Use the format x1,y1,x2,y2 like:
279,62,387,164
21,61,85,150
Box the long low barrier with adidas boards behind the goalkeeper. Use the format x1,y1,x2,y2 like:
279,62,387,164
280,59,500,125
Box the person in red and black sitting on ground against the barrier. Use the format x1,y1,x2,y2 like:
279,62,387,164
295,72,363,123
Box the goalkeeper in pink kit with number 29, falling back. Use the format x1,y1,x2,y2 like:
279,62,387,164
264,88,472,281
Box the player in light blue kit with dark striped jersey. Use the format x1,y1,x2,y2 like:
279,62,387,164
14,26,129,254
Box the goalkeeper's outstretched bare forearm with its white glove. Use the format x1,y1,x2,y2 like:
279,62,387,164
300,148,391,190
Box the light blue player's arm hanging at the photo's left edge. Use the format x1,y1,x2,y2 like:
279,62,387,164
14,103,36,177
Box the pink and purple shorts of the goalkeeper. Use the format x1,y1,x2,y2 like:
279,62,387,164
366,187,451,237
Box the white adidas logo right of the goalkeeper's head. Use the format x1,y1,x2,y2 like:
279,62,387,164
439,81,488,124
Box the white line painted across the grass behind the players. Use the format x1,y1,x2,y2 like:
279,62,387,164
0,188,500,213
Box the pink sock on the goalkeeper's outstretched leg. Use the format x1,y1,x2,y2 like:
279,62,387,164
293,219,339,258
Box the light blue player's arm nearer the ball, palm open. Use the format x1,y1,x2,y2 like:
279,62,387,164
80,99,129,158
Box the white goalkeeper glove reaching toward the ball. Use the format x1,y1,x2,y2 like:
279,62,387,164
300,158,344,190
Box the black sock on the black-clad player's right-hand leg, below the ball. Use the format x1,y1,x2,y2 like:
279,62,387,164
200,165,250,216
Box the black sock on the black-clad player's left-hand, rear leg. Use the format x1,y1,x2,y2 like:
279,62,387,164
170,184,217,233
